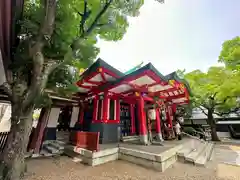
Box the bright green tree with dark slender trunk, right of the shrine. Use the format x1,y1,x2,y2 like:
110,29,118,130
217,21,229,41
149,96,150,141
185,67,240,141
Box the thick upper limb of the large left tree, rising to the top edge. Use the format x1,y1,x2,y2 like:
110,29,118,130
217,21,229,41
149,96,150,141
22,0,57,109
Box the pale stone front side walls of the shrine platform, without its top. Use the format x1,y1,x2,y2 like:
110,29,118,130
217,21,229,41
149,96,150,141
64,145,182,172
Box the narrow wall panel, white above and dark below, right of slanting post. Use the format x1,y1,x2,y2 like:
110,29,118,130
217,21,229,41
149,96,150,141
44,108,60,140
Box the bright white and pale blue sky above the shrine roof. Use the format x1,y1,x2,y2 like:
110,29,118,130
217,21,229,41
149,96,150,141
98,0,240,74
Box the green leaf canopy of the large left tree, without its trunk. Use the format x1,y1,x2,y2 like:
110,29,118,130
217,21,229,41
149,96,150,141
11,0,144,95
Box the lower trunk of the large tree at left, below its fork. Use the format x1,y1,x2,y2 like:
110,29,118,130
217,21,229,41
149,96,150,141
0,105,33,180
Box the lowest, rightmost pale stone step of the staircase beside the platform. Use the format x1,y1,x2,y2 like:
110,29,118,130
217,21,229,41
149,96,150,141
194,143,213,166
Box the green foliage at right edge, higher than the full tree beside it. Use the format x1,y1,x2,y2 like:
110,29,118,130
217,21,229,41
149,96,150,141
219,36,240,71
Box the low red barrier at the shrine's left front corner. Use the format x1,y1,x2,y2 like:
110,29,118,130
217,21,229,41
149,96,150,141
70,131,100,151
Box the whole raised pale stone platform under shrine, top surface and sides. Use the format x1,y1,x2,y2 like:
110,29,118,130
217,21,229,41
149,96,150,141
64,141,188,172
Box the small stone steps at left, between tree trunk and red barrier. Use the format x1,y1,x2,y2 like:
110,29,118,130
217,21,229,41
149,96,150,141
40,140,65,156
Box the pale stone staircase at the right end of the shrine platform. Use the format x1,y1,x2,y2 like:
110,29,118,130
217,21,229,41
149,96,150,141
177,138,214,166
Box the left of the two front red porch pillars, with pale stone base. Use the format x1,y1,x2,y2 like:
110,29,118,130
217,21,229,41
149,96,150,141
138,96,148,144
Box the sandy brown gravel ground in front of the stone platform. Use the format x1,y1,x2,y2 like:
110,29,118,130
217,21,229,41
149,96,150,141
25,157,240,180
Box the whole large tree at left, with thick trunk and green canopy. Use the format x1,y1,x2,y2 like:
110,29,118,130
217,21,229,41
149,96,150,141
0,0,143,180
